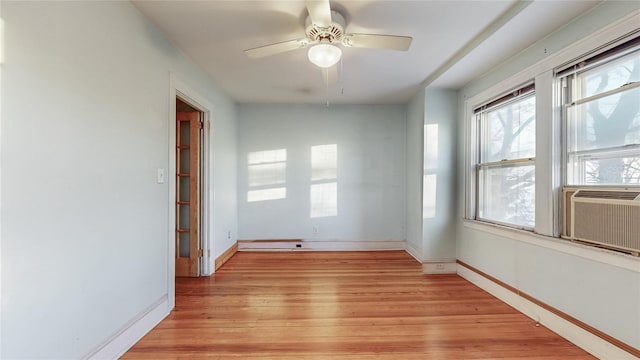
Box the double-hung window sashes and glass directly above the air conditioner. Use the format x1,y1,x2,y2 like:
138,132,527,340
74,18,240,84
556,38,640,186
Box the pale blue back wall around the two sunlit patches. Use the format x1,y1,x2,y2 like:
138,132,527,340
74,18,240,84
238,104,406,241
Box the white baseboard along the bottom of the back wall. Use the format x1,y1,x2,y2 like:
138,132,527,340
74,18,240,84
238,240,405,251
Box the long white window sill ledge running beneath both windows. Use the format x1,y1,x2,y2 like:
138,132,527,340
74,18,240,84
463,219,640,273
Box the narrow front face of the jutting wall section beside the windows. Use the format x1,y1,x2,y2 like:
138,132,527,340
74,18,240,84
422,88,458,261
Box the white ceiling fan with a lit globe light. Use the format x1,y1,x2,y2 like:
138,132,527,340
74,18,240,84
244,0,412,69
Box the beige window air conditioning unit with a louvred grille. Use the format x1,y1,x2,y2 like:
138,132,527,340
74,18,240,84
565,189,640,256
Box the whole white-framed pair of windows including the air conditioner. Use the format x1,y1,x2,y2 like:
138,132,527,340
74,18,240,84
464,16,640,255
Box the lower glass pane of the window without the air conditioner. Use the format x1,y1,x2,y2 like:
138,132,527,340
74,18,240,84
478,165,535,228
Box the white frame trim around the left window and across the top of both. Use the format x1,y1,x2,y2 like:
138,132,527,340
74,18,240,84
460,13,640,245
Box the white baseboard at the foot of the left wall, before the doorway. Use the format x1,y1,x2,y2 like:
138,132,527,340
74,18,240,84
82,295,171,360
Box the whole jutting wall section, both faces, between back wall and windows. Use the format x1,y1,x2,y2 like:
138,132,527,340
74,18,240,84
406,88,458,262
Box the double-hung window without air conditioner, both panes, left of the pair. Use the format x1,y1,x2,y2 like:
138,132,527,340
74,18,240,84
474,84,536,229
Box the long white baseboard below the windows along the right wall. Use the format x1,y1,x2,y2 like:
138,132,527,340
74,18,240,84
457,264,637,360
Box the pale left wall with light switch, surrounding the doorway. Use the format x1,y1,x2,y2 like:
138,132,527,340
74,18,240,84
0,2,236,359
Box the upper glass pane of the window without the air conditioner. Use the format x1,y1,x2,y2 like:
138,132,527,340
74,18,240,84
480,94,536,163
